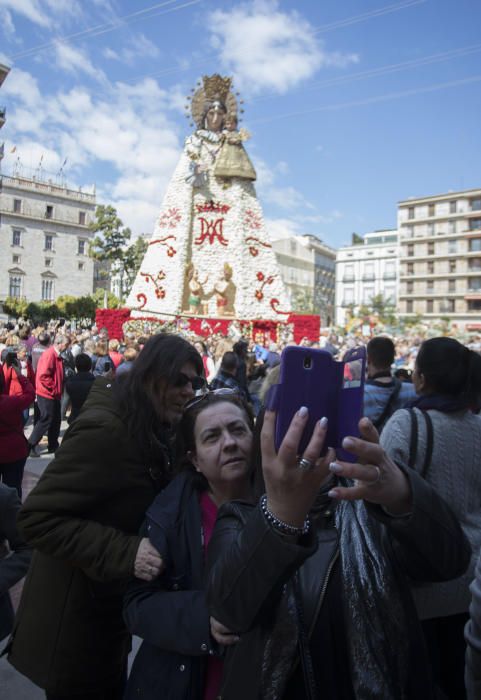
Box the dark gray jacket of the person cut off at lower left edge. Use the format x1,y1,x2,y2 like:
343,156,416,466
0,483,32,639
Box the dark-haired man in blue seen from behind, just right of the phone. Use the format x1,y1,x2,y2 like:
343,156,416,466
364,336,416,432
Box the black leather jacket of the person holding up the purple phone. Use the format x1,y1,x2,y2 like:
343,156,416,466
207,472,470,700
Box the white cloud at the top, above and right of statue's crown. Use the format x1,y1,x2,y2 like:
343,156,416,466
207,0,357,94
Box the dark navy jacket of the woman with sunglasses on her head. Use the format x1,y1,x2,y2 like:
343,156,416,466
124,473,214,700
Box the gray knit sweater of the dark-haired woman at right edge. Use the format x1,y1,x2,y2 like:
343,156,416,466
381,409,481,620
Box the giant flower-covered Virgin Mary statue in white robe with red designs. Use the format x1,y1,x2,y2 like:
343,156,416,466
127,74,288,320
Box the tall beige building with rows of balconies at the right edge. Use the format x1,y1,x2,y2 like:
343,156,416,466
398,189,481,330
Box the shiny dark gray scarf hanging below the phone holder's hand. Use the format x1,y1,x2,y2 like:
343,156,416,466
335,501,410,700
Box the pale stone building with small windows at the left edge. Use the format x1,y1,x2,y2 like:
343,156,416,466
0,175,95,303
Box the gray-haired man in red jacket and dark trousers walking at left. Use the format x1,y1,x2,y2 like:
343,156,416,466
29,335,69,457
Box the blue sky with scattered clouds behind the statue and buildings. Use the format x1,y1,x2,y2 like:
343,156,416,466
0,0,481,247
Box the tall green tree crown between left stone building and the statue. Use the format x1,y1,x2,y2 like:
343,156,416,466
89,204,132,263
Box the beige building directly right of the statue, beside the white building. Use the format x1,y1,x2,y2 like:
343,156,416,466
272,235,336,326
